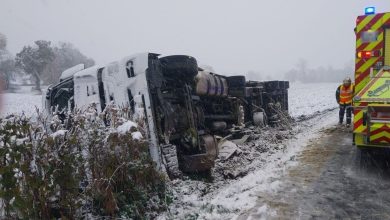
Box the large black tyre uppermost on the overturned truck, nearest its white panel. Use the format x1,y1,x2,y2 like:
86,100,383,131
160,55,198,79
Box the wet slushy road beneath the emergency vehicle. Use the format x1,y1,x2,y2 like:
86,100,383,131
238,126,390,219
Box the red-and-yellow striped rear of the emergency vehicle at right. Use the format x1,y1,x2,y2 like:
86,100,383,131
353,13,390,147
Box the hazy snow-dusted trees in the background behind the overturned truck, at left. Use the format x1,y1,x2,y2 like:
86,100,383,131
0,33,95,91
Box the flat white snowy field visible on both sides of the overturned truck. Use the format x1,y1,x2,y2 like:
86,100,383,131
0,83,337,117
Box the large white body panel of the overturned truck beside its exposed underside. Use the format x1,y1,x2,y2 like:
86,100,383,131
99,53,162,168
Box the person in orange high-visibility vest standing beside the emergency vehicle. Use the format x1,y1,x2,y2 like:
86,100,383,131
336,77,354,127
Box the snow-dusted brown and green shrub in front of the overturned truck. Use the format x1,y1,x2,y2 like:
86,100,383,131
0,106,166,219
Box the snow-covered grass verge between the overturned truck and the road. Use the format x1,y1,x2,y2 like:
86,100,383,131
160,110,337,219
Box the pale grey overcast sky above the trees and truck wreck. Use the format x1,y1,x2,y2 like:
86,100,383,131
0,0,390,77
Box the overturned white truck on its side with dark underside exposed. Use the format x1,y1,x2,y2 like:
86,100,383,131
44,53,289,177
